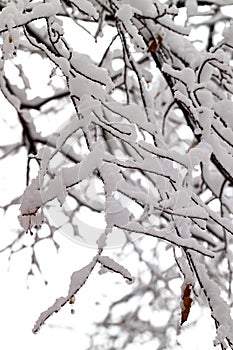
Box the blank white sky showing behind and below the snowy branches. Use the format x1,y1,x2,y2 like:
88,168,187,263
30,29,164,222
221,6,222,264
0,9,226,350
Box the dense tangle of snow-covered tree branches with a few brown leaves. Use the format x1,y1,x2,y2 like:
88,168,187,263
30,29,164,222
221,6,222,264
0,0,233,349
